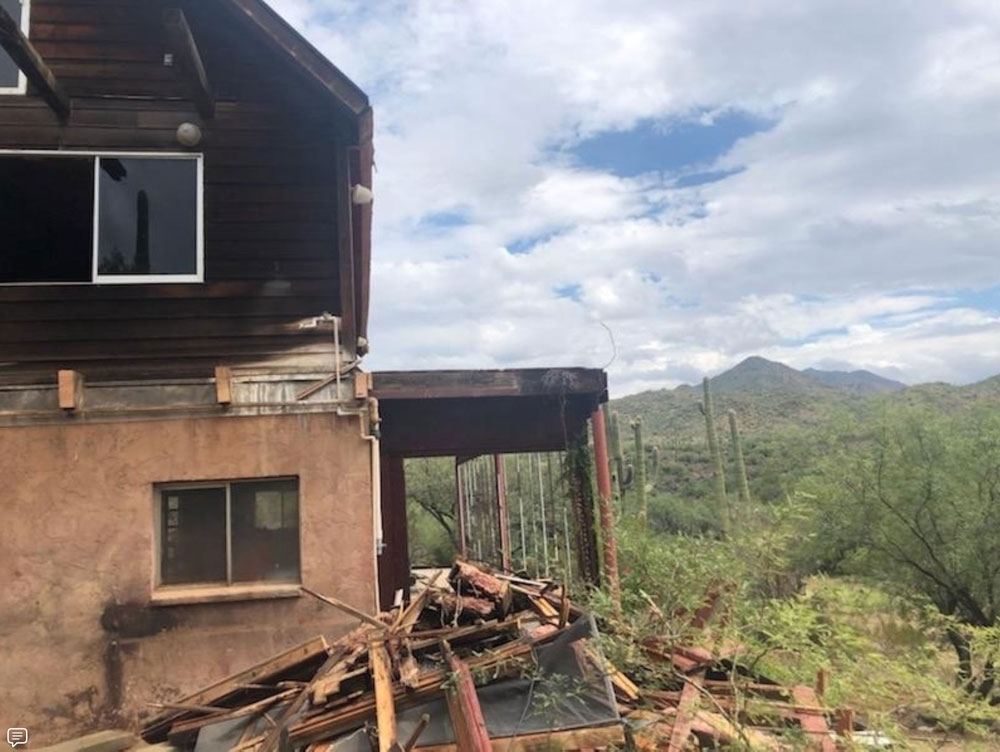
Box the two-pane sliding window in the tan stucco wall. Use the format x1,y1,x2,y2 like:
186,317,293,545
156,477,301,588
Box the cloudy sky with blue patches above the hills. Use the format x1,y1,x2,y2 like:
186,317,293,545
271,0,1000,396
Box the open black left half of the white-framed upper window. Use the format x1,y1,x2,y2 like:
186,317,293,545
0,155,94,282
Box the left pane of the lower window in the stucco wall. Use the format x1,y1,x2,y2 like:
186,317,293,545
160,487,226,585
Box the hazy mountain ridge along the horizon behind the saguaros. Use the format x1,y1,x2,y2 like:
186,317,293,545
611,356,1000,440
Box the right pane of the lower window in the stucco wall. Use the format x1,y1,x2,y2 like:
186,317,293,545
232,479,299,582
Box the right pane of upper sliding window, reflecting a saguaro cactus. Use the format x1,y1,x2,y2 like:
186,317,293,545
97,157,198,275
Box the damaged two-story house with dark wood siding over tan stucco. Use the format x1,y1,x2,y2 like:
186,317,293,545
0,0,606,742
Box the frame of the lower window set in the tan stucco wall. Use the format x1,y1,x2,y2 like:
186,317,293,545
153,475,302,592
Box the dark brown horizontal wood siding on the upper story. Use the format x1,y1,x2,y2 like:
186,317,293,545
0,0,349,384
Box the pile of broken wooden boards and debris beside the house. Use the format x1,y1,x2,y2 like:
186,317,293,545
142,561,851,752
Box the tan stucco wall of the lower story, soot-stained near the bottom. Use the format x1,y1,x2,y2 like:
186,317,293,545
0,414,375,746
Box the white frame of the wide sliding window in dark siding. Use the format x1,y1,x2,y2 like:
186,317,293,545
0,149,205,287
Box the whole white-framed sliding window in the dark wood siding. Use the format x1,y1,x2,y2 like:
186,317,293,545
0,153,204,284
